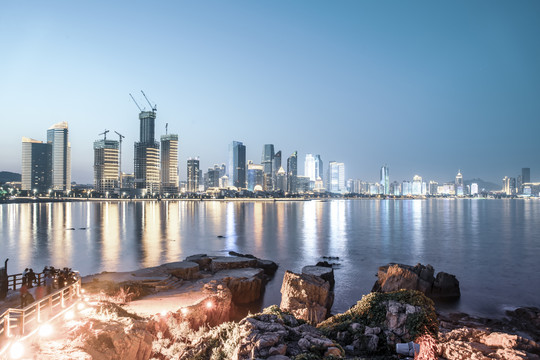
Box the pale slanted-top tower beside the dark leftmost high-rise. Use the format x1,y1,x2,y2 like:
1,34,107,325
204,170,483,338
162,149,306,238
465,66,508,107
47,121,71,191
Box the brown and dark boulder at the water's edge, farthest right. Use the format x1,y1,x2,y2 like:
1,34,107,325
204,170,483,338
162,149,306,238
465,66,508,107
371,264,461,299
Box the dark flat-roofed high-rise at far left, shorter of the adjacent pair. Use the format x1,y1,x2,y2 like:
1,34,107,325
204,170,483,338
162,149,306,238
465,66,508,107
21,137,52,193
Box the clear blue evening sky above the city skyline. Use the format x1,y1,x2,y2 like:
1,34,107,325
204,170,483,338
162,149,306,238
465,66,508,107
0,0,540,184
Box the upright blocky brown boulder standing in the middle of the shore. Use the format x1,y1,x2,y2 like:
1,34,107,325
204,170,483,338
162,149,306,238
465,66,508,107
280,270,334,324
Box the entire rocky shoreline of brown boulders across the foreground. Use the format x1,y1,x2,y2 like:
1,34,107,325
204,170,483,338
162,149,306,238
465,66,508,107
13,253,540,360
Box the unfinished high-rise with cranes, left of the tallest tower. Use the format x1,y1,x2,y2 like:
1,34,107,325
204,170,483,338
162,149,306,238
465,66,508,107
94,139,119,193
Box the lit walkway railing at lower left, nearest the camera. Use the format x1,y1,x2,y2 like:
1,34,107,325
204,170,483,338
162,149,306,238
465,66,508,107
0,277,81,340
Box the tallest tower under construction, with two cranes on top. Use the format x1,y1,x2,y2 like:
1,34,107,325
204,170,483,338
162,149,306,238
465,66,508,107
134,109,160,194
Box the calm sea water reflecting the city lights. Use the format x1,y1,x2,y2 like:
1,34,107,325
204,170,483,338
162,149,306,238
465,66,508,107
0,199,540,316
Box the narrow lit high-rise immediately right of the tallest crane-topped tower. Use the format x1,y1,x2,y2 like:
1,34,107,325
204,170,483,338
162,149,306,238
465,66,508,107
161,134,179,194
